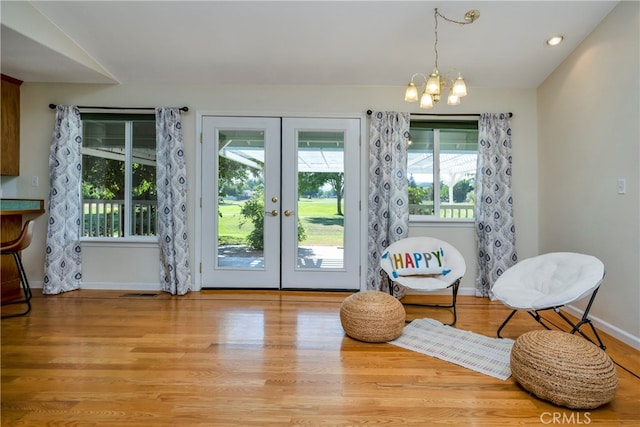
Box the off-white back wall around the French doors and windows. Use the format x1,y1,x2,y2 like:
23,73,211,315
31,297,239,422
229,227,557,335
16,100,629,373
2,83,538,294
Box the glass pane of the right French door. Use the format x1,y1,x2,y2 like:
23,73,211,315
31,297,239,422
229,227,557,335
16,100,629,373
296,131,346,269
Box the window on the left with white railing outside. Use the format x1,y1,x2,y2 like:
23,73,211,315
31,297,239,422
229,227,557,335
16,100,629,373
82,114,157,238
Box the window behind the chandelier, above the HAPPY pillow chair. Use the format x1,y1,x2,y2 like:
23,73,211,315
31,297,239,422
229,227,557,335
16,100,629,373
407,121,478,221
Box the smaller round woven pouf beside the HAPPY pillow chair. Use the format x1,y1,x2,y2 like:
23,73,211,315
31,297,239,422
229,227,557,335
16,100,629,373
340,291,406,342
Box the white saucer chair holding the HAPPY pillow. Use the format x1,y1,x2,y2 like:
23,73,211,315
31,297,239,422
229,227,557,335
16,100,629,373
380,237,467,326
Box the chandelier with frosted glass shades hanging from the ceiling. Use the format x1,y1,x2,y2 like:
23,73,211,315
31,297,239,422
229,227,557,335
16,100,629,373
404,8,480,109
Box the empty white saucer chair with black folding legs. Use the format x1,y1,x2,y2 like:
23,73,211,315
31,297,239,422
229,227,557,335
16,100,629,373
492,252,605,350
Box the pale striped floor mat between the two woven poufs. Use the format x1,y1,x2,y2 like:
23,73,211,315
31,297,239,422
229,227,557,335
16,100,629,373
389,319,514,380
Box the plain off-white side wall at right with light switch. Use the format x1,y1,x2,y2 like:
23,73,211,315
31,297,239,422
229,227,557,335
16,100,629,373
538,2,640,347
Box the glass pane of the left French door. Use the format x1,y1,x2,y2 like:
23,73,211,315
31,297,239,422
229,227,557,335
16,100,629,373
216,130,267,269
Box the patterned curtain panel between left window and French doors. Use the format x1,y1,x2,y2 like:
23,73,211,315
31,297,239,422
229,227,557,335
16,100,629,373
156,108,191,295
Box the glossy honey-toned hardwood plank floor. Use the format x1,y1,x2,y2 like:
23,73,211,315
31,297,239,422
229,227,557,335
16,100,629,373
1,290,640,427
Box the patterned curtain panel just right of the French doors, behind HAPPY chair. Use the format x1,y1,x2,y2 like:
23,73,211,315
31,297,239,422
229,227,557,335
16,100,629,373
367,111,410,297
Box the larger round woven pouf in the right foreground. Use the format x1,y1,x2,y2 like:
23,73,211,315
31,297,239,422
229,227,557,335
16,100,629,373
511,330,618,409
